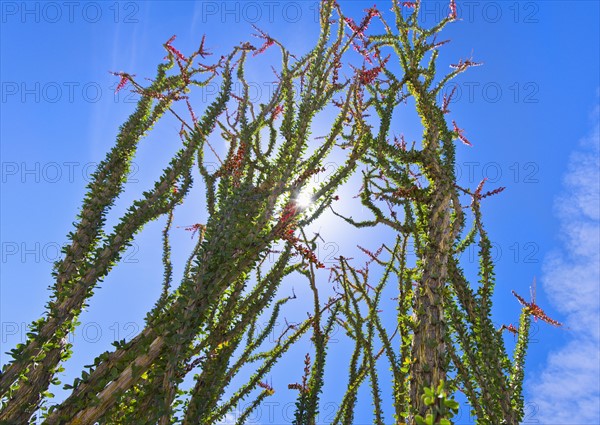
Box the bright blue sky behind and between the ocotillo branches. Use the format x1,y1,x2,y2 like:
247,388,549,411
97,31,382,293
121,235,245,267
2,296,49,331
0,0,600,425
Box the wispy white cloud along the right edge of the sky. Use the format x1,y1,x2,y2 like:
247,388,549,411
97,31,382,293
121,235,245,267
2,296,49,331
528,98,600,425
